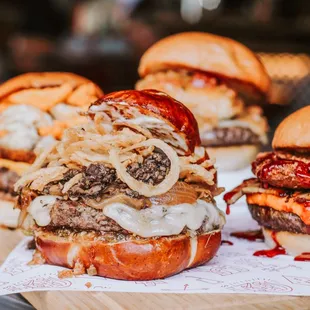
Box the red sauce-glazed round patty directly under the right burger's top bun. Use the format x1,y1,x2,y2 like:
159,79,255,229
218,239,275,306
252,152,310,189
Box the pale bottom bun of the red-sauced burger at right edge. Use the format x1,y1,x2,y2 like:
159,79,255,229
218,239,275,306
263,228,310,256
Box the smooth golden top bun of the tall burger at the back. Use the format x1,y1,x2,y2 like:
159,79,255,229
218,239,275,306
138,32,270,100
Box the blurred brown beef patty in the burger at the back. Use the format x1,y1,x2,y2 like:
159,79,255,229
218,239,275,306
201,127,261,146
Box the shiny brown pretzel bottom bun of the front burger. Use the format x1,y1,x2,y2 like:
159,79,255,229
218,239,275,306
35,231,221,281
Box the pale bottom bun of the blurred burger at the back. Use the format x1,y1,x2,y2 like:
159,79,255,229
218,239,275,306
206,145,260,171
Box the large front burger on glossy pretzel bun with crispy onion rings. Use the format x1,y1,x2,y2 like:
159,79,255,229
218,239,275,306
15,90,225,280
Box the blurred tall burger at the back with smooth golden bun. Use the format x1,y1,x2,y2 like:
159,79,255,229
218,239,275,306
136,32,270,171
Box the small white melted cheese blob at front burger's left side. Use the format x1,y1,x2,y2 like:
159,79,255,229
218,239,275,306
28,195,59,226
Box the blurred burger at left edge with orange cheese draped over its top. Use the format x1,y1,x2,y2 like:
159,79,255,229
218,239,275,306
0,72,102,228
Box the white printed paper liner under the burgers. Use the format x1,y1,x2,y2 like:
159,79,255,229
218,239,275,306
0,204,310,296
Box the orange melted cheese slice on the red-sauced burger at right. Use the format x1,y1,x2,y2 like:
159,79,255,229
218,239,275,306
246,193,310,225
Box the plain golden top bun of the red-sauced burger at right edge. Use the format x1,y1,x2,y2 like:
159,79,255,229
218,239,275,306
272,106,310,150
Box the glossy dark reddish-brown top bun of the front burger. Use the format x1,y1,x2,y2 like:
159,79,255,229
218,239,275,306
89,89,200,154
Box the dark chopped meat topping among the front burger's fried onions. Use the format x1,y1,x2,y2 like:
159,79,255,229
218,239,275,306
43,152,170,199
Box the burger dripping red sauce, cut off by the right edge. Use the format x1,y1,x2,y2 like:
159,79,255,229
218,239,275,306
224,106,310,256
